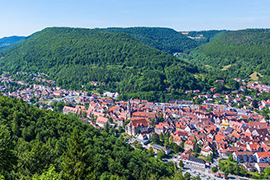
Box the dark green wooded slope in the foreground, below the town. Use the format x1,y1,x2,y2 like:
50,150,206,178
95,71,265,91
0,95,179,180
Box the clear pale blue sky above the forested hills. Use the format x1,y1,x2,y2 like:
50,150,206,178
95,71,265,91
0,0,270,38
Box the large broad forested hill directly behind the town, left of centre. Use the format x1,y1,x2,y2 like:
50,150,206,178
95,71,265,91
0,28,207,101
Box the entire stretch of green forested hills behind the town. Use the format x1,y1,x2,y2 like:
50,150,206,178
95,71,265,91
0,27,270,102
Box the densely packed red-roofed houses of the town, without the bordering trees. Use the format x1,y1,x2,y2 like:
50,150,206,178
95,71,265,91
0,73,270,172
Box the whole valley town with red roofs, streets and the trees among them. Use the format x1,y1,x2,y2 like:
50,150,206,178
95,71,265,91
0,72,270,179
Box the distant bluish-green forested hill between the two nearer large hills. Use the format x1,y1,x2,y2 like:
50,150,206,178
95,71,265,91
104,27,200,54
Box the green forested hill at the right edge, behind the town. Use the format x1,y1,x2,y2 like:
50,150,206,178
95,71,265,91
191,29,270,83
